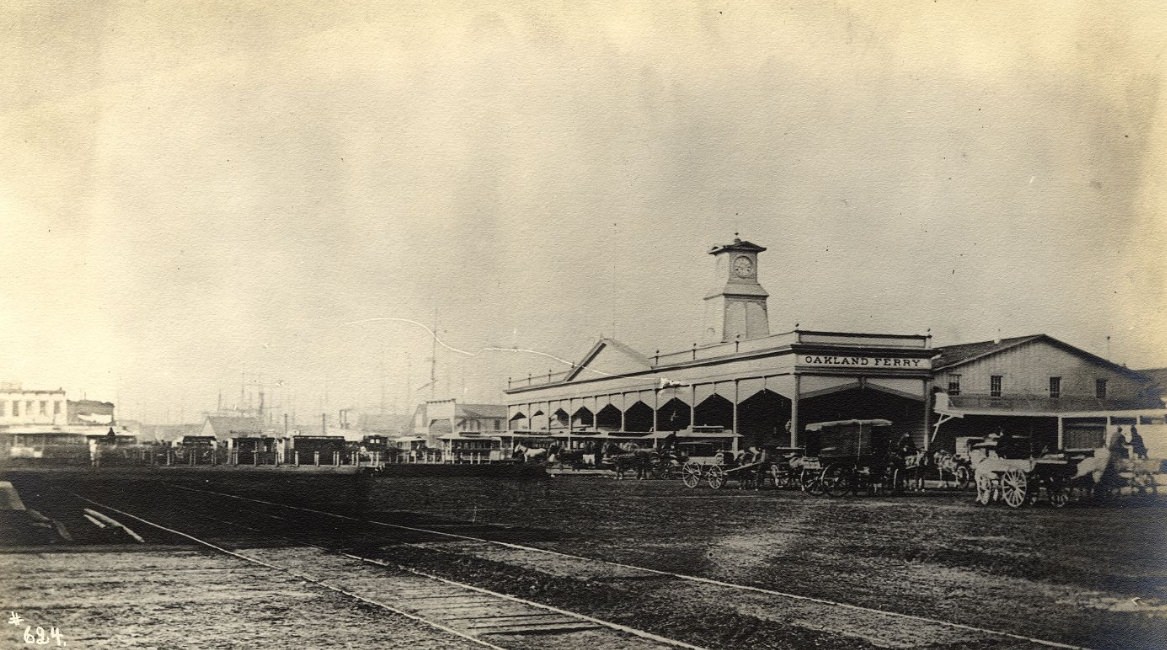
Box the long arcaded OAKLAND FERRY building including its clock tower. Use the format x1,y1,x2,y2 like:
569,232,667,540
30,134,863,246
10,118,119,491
505,238,937,448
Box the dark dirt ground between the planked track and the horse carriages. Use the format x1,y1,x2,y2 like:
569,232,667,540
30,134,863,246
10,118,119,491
2,475,1167,648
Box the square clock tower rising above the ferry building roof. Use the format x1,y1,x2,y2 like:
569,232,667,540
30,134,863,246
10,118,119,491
705,237,770,343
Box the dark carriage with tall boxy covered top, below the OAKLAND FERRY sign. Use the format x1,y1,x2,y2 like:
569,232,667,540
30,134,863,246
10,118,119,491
804,419,920,496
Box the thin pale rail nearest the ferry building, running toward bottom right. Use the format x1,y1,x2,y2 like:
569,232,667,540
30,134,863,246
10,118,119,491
155,484,1089,650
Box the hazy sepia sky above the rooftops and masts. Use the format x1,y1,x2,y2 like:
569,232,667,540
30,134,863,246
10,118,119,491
0,0,1167,422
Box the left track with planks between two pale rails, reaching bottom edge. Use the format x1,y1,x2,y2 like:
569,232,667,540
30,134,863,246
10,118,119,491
74,485,704,650
